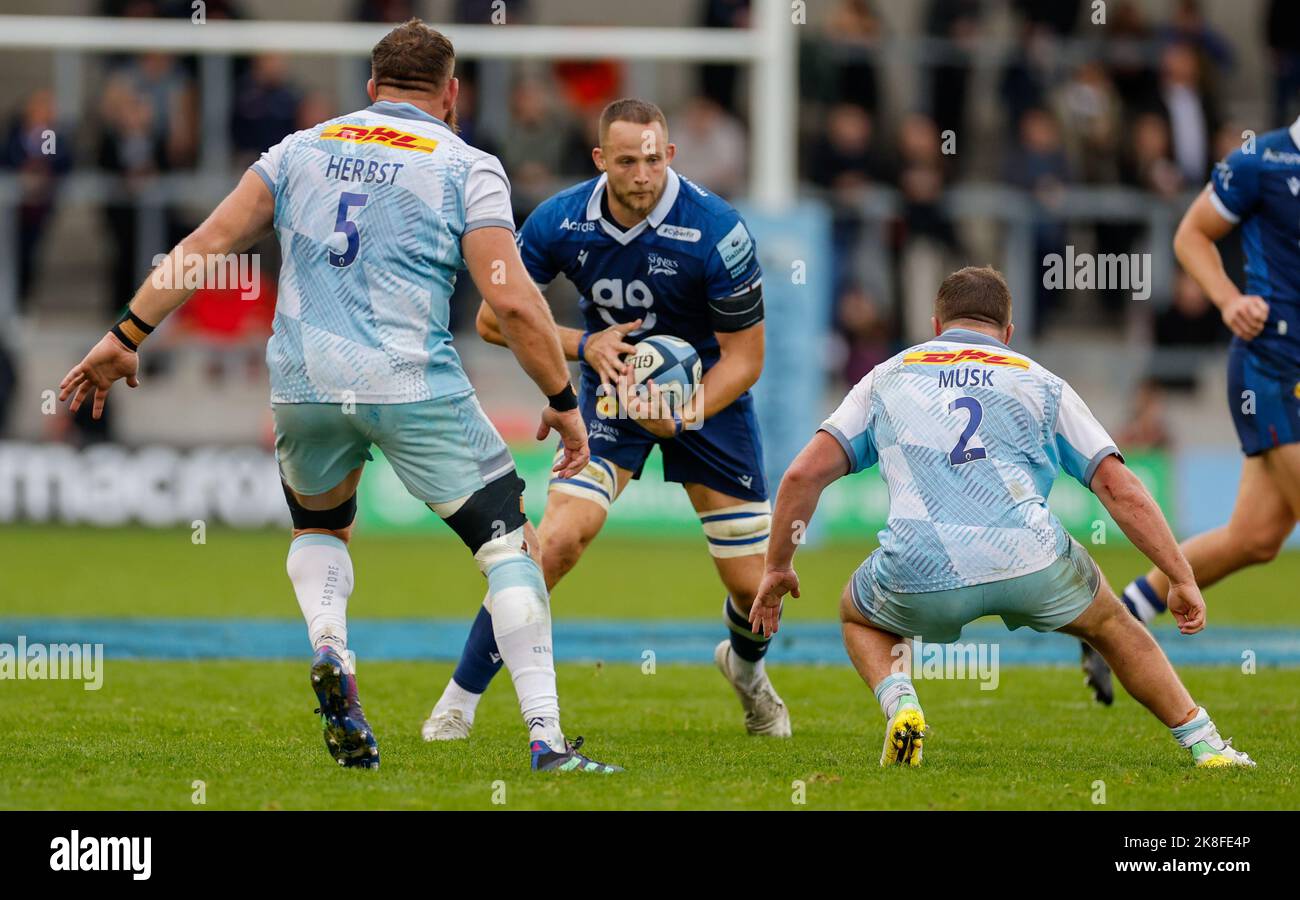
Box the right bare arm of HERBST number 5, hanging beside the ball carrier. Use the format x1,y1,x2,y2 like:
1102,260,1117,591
460,226,592,477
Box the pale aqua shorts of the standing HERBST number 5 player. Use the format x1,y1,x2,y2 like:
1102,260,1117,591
270,390,515,503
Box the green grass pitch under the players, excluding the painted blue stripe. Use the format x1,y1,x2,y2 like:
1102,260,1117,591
0,528,1300,809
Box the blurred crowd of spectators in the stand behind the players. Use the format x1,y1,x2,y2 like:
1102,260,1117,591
0,0,1300,442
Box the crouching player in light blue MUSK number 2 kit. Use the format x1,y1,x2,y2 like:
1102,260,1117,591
750,268,1255,766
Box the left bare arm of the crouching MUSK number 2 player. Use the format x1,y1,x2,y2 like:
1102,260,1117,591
749,432,849,636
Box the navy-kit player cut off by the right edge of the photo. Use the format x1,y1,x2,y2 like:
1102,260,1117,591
1083,118,1300,704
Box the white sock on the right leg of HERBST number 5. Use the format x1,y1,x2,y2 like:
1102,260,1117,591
488,555,564,750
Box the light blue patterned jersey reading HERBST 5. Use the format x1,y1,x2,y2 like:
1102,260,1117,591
252,100,514,403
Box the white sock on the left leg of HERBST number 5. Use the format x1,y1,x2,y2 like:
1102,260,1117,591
285,533,352,659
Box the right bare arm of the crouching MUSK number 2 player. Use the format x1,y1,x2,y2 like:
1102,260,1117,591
1089,457,1205,635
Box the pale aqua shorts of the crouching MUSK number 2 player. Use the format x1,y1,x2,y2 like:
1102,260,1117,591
849,537,1101,644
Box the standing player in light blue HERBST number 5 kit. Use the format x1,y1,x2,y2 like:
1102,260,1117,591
60,20,619,773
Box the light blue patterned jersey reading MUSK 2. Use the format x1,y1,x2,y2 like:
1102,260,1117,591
822,328,1119,593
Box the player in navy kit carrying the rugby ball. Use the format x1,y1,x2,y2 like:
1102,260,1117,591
423,99,790,740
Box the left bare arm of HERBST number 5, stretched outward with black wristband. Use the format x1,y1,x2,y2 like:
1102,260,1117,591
59,172,276,419
